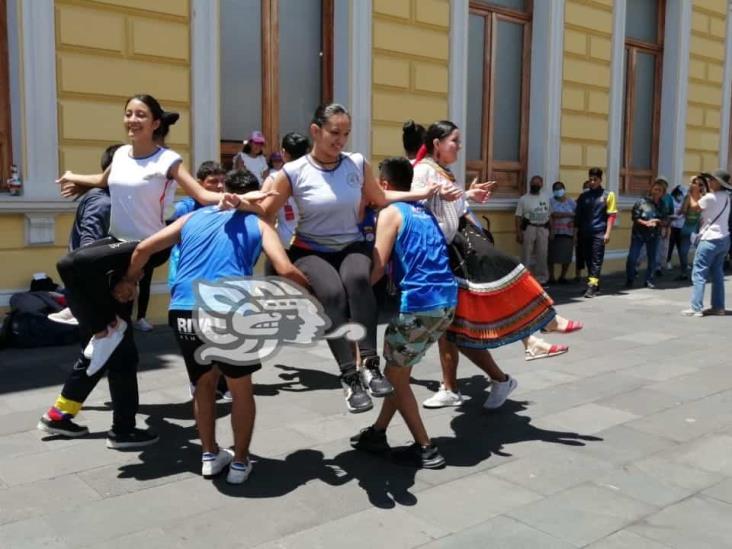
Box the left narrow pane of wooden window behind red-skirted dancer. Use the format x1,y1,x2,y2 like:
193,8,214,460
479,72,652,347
465,15,485,160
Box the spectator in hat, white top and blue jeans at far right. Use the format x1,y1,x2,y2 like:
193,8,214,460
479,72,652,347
681,169,732,317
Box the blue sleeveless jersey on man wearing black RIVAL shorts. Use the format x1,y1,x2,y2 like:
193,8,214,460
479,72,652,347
170,206,262,311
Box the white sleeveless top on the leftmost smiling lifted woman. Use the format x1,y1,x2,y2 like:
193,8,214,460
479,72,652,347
107,145,181,240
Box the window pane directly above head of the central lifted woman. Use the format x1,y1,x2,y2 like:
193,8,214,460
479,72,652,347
279,0,322,138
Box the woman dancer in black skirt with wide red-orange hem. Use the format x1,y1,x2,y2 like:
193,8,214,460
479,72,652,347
412,120,581,409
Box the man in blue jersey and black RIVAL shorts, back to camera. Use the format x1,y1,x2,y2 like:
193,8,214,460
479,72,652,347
115,171,308,484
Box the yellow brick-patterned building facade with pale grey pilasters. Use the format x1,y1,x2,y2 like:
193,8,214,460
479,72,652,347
0,0,732,321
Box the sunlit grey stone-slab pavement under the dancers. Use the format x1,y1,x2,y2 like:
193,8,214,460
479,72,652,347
0,275,732,549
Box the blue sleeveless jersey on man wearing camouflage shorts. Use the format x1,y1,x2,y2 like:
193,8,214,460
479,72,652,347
392,202,457,313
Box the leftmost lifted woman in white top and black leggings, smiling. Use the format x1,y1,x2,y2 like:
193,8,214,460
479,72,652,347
58,95,264,406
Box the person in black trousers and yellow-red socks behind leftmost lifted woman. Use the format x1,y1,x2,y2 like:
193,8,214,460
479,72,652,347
38,145,147,448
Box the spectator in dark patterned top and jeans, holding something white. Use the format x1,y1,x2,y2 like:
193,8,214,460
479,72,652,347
625,180,665,288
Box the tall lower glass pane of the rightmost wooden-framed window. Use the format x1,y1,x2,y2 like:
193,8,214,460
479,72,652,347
630,52,656,169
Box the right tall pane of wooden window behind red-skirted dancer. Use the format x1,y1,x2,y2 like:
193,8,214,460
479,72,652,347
491,19,524,162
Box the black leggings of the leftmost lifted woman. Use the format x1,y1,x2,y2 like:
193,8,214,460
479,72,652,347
56,236,170,333
